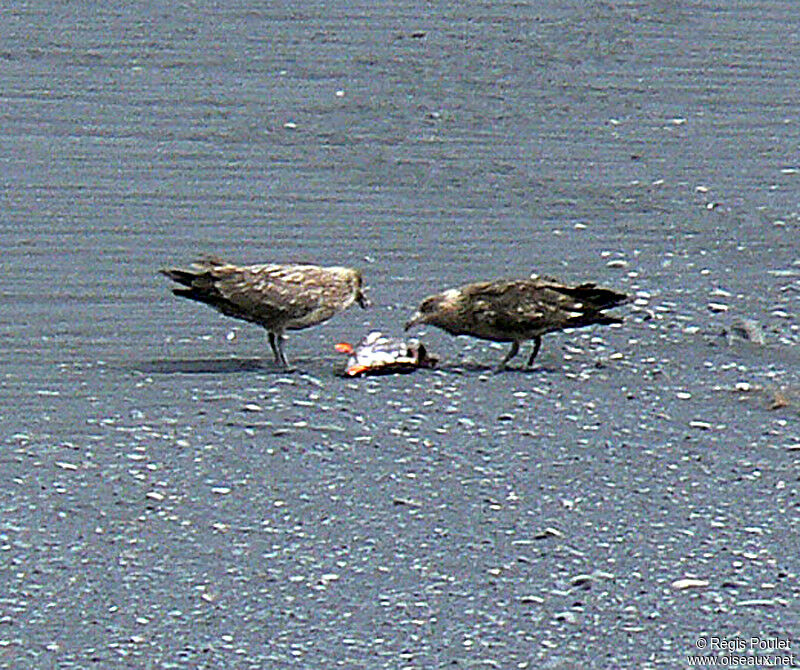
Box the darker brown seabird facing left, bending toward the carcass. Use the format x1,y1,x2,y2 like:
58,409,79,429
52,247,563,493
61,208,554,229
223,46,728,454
406,275,629,369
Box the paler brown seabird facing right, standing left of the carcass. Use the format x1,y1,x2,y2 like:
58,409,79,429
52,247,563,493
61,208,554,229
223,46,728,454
160,258,369,367
